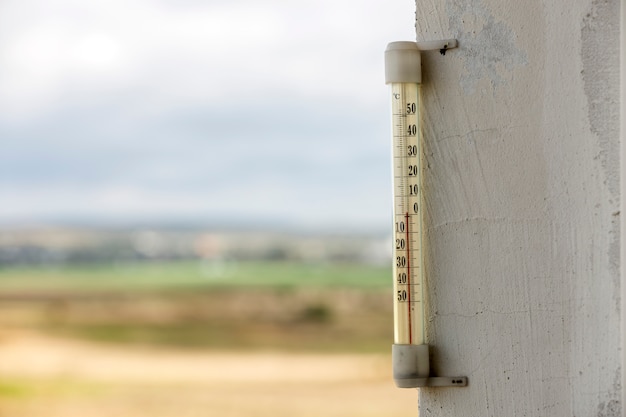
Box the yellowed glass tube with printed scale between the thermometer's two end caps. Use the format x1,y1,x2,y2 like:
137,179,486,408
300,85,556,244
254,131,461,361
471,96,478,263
391,83,425,345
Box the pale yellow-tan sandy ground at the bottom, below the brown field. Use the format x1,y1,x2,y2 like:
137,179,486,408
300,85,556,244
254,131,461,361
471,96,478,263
0,332,417,417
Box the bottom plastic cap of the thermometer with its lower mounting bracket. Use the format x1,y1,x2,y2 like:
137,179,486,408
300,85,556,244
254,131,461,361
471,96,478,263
391,345,467,388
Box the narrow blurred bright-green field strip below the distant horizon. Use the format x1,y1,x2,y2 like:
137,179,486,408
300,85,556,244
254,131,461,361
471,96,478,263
0,261,391,293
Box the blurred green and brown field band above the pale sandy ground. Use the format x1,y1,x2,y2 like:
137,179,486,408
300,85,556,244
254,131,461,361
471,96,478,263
0,261,392,352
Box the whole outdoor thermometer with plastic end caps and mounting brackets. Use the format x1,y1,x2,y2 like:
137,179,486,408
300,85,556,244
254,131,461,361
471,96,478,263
385,40,467,388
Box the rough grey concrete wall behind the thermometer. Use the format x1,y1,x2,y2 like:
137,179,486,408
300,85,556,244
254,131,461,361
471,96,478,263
416,0,622,417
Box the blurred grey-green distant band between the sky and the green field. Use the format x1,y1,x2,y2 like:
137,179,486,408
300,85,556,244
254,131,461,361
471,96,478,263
0,224,391,268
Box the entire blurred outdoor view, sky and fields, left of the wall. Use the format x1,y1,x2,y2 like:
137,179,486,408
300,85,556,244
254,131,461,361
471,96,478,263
0,0,415,417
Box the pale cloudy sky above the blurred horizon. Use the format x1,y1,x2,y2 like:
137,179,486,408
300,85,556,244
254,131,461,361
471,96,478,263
0,0,415,231
